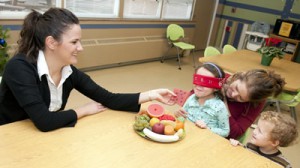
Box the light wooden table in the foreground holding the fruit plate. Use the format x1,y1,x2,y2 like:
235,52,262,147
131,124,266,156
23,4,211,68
0,104,280,168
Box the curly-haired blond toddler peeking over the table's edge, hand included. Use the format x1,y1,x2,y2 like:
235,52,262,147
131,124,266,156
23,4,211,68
230,111,298,168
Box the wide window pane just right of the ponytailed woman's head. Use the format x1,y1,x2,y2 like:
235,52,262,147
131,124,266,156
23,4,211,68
64,0,120,18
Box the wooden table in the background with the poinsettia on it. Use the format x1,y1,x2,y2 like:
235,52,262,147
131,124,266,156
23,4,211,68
199,50,300,92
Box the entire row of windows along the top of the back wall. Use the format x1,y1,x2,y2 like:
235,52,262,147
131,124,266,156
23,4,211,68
0,0,196,20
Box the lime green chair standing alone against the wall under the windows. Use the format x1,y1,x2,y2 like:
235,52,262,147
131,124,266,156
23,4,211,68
160,24,196,70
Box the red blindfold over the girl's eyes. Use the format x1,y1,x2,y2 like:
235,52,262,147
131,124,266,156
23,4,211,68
193,74,225,89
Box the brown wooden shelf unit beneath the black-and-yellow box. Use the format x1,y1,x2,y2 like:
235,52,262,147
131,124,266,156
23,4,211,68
270,34,300,63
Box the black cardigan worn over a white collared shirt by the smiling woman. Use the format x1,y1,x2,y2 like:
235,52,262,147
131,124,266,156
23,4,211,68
0,54,140,131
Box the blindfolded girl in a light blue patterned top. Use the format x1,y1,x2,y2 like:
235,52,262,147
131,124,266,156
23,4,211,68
175,62,230,137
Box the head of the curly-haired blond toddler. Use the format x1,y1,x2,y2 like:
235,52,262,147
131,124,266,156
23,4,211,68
250,111,298,147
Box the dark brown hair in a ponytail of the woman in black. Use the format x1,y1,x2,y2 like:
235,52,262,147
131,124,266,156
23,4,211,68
17,8,79,62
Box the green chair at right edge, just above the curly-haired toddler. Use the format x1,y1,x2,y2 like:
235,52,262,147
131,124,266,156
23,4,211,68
267,91,300,121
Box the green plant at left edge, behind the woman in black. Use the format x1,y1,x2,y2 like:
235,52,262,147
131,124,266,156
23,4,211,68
0,25,9,81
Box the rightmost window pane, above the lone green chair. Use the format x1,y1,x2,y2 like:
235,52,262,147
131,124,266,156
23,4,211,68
162,0,194,20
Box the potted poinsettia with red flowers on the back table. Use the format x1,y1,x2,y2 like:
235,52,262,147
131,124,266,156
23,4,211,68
257,40,284,66
